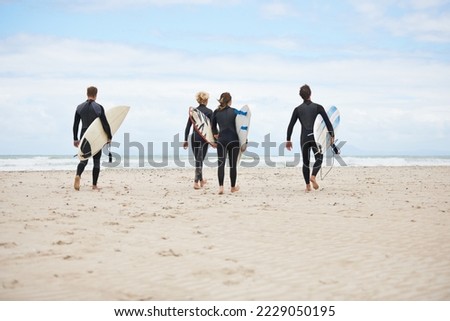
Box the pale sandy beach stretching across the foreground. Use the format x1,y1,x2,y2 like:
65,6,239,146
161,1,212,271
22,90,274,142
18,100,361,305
0,167,450,300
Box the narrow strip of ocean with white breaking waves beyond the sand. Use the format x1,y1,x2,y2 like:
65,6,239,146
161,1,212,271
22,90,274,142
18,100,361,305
0,154,450,171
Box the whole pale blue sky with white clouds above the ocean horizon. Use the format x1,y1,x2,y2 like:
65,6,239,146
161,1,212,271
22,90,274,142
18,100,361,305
0,0,450,156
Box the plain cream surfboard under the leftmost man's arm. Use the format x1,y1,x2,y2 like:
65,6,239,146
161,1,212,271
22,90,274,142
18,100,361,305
77,106,130,160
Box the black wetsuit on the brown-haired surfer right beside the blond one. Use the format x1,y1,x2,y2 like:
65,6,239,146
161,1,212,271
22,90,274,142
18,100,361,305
212,107,240,187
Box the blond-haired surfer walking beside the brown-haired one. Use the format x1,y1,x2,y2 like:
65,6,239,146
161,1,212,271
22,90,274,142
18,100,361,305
183,91,212,189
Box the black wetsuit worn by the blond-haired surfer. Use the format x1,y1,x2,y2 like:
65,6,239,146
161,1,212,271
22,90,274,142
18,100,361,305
184,104,212,183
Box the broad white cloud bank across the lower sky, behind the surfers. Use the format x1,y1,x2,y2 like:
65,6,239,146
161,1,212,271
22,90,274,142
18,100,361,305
0,35,450,154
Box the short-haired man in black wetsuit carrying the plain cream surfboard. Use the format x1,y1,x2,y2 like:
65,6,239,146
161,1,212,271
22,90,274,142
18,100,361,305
73,86,112,191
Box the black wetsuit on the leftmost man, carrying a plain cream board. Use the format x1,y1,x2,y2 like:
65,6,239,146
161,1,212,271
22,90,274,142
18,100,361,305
73,99,112,186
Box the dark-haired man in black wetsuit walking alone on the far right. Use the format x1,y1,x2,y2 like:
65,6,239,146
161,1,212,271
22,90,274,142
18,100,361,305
286,85,334,192
